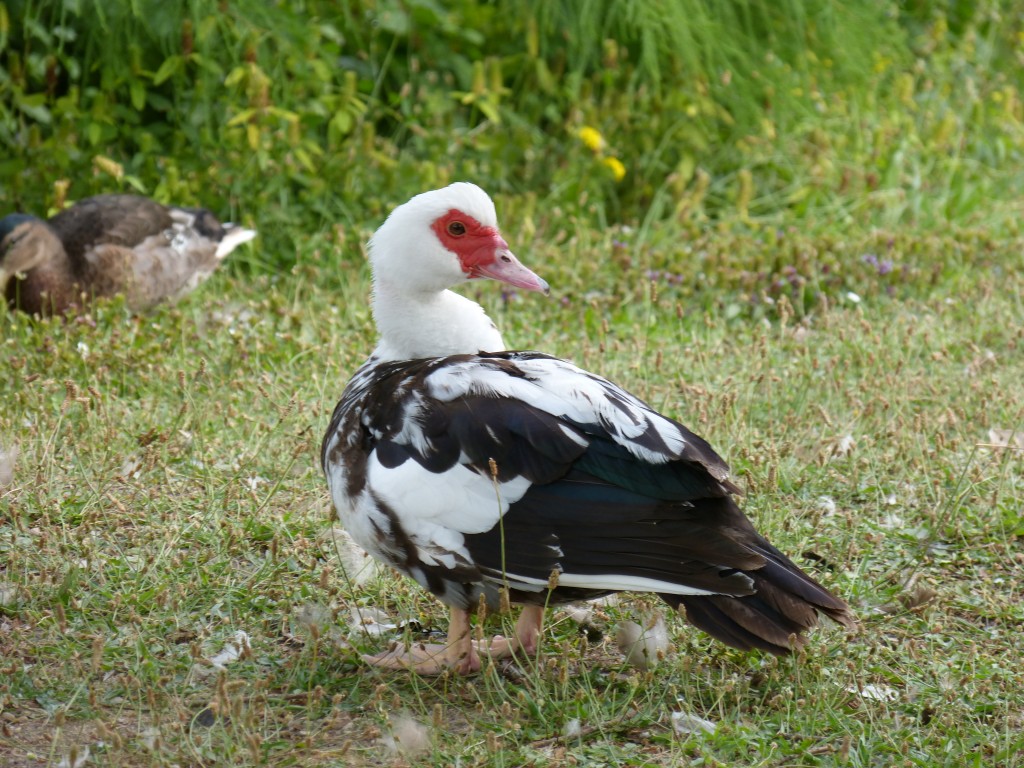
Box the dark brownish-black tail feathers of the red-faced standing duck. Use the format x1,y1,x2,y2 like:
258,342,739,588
659,539,856,655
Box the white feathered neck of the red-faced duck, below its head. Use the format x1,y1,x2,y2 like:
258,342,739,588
373,280,505,361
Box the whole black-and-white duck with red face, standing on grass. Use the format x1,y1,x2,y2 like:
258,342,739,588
322,184,853,672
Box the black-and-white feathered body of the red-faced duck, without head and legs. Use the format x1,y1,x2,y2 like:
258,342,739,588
323,352,852,652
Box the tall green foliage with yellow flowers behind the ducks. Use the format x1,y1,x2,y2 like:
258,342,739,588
0,0,1024,266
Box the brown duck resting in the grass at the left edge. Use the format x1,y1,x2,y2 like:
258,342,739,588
0,195,256,315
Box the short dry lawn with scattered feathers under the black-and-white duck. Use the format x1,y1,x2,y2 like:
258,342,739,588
0,211,1024,766
